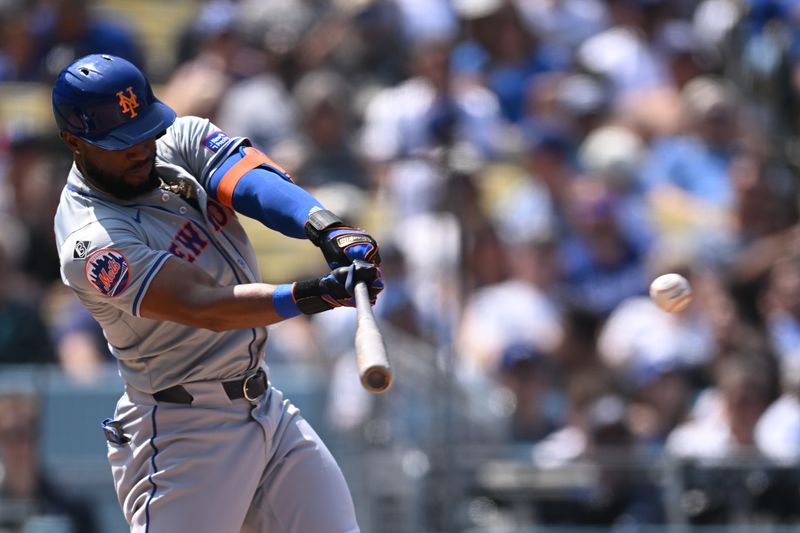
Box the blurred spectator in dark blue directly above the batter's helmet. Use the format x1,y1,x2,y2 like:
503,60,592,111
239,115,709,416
34,0,146,81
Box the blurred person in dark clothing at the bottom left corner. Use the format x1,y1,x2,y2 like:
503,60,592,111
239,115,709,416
0,392,100,533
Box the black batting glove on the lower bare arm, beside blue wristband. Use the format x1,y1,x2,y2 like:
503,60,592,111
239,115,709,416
292,259,383,315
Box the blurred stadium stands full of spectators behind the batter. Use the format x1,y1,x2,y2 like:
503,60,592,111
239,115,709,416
0,0,800,533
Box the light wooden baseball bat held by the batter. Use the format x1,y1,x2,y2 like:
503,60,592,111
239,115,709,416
355,281,392,393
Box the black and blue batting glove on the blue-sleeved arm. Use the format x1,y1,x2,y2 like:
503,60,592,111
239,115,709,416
305,209,381,269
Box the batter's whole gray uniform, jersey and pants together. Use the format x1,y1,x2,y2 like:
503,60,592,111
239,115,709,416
55,117,358,533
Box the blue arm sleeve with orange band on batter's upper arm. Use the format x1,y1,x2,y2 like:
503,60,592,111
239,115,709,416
208,148,323,239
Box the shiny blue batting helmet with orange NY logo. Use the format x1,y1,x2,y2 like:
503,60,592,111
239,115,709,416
53,54,175,150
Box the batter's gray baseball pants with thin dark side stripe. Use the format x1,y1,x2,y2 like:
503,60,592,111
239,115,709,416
108,374,359,533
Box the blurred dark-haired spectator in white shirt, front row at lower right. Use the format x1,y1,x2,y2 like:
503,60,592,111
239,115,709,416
667,352,798,527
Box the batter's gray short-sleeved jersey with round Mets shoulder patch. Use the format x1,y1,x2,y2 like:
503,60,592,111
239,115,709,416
55,117,267,393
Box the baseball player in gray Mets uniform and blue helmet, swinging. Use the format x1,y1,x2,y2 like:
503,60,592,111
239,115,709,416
53,55,383,533
